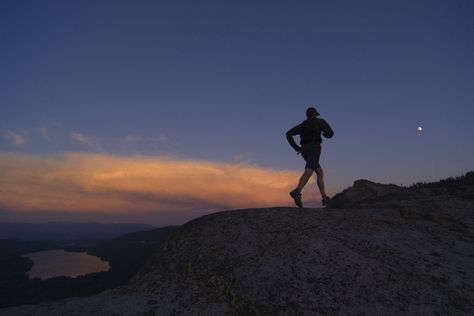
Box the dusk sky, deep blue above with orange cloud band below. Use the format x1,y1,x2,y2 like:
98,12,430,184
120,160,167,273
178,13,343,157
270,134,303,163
0,0,474,226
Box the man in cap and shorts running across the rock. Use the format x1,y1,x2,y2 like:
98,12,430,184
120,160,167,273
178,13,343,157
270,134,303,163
286,107,334,207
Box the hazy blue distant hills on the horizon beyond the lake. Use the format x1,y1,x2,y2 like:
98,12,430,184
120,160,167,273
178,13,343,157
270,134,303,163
0,222,155,241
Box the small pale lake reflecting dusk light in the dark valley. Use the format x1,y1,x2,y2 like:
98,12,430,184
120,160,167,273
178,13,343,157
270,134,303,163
23,249,110,280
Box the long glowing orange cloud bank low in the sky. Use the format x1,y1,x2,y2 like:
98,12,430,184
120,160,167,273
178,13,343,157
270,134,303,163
0,153,314,217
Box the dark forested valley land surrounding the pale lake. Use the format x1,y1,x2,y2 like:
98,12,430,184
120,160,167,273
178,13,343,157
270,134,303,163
0,227,176,307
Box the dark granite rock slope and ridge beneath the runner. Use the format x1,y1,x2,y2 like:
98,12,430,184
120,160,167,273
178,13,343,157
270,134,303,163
0,180,474,316
